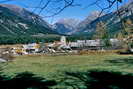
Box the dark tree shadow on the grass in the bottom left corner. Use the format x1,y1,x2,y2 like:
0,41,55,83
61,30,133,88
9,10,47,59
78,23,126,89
0,72,56,89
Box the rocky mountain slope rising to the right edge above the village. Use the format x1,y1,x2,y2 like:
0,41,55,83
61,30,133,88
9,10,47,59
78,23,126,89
74,2,133,34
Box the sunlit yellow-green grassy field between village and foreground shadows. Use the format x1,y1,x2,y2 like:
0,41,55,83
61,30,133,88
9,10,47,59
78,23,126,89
1,54,133,78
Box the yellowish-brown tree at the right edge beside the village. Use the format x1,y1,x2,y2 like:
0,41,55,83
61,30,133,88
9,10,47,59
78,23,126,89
116,19,133,50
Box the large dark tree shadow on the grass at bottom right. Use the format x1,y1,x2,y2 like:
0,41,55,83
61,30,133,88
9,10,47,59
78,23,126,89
63,71,133,89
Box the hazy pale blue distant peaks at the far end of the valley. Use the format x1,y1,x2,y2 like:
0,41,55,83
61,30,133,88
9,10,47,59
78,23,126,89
54,11,104,35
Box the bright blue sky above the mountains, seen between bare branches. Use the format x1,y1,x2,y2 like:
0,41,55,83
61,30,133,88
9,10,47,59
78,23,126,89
0,0,128,23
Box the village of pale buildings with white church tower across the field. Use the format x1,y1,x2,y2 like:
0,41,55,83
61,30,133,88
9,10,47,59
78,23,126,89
0,36,133,60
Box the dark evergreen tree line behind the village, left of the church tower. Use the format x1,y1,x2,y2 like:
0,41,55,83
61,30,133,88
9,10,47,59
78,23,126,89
0,36,60,44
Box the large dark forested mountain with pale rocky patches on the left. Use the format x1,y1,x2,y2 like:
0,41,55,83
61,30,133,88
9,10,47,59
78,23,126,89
0,4,57,36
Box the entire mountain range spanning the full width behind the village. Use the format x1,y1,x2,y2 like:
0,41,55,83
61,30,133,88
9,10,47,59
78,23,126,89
0,2,133,36
